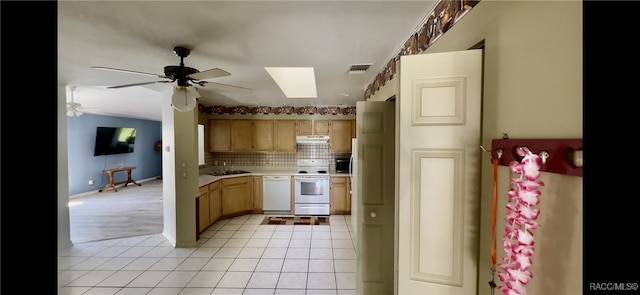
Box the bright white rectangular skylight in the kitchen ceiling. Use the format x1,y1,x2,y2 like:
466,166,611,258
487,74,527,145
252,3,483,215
264,67,318,98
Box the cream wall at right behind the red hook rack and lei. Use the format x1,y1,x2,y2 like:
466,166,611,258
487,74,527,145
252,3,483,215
426,0,583,295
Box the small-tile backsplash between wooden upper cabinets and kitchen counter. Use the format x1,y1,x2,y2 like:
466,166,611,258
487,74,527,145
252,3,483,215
205,143,351,170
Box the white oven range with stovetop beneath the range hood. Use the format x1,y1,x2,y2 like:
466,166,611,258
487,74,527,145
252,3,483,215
293,159,330,215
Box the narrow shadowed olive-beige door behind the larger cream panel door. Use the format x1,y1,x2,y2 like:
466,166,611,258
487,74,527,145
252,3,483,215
352,101,396,295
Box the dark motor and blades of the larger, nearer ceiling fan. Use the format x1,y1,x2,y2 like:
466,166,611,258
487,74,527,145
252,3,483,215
91,46,251,90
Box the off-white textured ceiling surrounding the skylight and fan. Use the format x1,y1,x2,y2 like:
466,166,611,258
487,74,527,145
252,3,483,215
58,1,435,121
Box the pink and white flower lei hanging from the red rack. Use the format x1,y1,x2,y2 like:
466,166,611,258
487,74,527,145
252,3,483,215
498,147,544,295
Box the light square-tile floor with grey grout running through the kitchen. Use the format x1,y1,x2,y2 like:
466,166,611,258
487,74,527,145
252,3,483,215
58,214,356,295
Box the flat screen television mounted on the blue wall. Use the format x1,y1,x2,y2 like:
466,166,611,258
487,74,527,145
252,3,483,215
93,127,136,156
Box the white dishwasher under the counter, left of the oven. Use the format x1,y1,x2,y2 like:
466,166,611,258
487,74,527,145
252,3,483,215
262,175,291,215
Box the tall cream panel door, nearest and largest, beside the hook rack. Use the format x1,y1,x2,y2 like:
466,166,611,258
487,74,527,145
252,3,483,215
396,49,482,295
